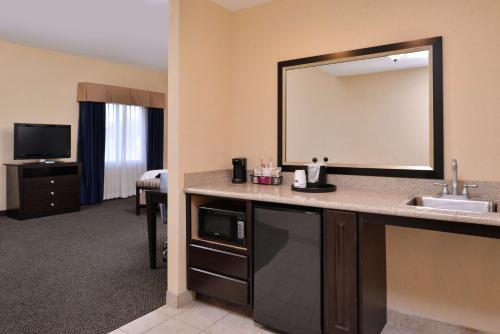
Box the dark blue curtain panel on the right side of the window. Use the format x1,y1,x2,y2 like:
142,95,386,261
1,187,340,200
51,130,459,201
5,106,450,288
146,108,164,170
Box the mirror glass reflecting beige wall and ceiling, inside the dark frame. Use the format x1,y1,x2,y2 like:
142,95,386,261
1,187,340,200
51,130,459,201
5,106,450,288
283,47,433,170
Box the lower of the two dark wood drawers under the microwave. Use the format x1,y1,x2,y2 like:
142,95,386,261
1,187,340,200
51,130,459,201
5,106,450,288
188,268,248,305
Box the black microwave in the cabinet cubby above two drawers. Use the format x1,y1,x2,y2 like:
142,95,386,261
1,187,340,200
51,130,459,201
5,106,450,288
198,204,246,246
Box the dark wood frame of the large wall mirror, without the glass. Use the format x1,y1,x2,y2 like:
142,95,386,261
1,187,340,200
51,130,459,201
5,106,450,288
278,37,444,179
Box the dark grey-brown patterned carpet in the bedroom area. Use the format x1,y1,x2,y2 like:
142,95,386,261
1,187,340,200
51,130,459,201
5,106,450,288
0,198,167,334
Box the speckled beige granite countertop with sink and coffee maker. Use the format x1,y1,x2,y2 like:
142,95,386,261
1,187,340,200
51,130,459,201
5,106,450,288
184,182,500,227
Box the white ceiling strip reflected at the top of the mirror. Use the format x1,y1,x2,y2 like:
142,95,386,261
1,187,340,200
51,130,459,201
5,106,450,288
320,50,429,77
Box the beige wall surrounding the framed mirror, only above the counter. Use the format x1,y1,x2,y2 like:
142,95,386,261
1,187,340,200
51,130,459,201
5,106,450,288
231,0,500,181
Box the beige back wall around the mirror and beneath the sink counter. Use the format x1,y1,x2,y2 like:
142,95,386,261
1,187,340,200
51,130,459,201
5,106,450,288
227,0,500,332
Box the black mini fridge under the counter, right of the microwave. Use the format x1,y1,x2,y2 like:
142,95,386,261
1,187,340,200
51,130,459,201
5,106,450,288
253,206,322,334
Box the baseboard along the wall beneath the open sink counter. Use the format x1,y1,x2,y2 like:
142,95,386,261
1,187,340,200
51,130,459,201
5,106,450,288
387,309,492,334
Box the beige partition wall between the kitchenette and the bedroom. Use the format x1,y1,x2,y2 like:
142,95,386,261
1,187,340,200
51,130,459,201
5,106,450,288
167,0,231,305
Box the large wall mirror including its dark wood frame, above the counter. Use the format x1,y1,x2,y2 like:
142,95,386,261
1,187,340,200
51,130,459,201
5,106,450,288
278,37,443,178
